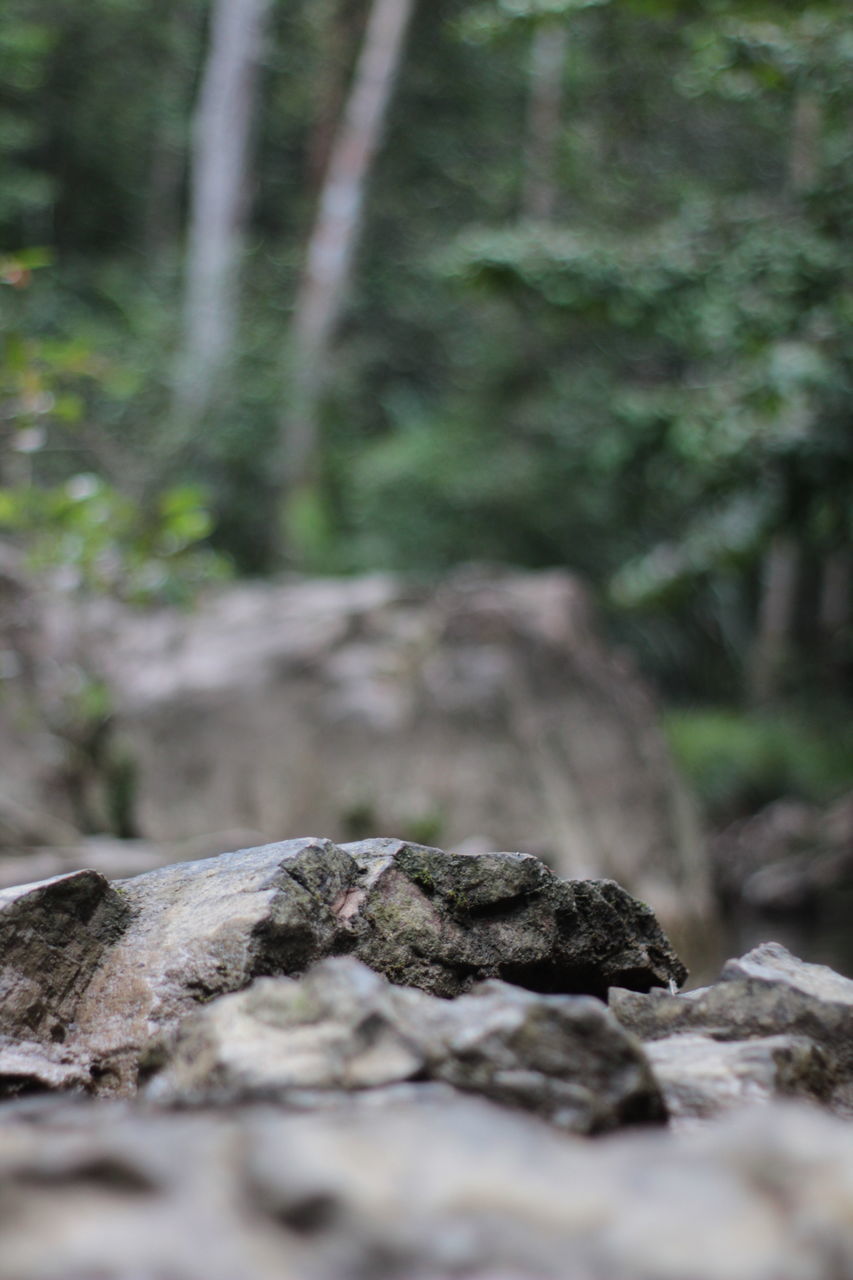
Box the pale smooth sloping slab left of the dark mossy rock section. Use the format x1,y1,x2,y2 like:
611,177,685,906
68,840,357,1093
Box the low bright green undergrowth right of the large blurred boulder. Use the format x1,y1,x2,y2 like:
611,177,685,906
666,708,853,823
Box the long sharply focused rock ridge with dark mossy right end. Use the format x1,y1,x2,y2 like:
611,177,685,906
0,840,685,1093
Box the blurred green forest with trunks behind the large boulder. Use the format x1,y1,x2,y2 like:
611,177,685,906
0,0,853,820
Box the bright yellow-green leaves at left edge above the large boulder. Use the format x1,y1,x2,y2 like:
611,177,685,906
0,250,229,603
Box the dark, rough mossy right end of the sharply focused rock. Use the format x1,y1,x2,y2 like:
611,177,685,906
343,840,686,998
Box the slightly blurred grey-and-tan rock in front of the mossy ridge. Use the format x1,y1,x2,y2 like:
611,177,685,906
145,957,665,1133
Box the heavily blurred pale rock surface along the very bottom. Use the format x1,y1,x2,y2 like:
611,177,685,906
0,1087,853,1280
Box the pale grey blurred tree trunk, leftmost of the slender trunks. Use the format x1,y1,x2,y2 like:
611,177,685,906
174,0,270,438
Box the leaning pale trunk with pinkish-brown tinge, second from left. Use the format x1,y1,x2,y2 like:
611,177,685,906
277,0,415,550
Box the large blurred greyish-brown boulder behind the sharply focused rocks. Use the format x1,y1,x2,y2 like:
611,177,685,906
0,572,712,942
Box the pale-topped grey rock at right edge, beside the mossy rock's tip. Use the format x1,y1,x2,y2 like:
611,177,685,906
610,942,853,1116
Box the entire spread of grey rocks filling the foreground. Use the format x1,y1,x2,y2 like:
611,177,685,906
0,840,853,1280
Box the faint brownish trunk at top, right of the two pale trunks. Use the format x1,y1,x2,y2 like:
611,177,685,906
521,17,569,223
